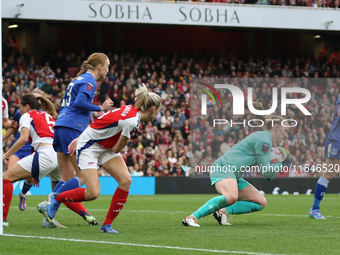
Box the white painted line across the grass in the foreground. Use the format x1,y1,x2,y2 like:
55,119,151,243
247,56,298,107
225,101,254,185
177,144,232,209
4,234,290,255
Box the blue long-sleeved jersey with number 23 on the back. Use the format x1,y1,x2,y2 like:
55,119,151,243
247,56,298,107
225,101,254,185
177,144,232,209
55,72,100,132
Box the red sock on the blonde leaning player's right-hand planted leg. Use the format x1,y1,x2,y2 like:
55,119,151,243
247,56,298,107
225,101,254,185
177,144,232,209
103,187,129,226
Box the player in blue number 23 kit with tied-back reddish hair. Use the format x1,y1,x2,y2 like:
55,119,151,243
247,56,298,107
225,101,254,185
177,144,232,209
38,53,113,225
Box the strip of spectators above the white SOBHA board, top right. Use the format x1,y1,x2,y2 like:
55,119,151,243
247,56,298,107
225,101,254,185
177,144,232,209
183,0,340,9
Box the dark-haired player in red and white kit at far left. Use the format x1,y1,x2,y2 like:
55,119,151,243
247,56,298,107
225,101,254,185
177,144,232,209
2,95,60,224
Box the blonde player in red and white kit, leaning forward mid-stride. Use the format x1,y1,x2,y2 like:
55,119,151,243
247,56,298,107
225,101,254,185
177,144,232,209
39,84,162,233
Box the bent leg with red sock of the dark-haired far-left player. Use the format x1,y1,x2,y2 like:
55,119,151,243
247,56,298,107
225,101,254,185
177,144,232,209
2,163,32,221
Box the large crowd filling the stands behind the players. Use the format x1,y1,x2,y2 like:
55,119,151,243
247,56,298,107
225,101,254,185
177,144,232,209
2,41,340,176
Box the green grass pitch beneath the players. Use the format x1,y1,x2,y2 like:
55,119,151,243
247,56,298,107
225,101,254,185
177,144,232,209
0,195,340,255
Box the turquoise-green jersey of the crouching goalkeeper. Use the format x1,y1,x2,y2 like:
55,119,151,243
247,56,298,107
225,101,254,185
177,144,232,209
210,131,282,180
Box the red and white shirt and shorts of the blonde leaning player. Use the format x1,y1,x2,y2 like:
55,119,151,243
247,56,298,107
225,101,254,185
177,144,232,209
77,105,140,170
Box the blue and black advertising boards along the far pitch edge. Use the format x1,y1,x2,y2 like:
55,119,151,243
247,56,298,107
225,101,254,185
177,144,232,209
13,177,340,195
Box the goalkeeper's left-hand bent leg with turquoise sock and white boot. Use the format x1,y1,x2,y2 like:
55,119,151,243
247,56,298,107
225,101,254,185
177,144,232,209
182,178,238,227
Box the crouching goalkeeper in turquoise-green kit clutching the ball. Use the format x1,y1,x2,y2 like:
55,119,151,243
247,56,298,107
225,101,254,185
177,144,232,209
182,102,290,227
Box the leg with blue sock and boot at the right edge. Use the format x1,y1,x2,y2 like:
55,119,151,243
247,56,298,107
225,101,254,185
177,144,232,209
308,158,340,219
